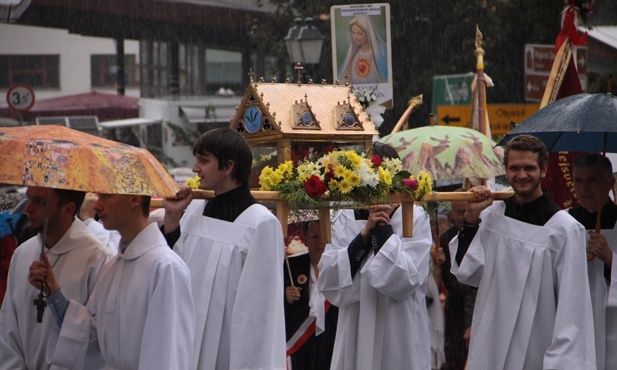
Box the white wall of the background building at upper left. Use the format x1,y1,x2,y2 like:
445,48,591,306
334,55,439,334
0,23,139,107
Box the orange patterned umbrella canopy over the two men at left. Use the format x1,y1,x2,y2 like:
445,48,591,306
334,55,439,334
0,126,179,197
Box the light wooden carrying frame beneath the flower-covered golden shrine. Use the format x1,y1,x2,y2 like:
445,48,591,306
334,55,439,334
150,190,514,243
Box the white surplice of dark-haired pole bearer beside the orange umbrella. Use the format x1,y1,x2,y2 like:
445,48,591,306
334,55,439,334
174,200,286,370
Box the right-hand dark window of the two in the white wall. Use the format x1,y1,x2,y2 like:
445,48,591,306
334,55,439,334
90,54,139,88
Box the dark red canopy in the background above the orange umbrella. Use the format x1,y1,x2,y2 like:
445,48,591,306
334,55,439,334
0,92,139,121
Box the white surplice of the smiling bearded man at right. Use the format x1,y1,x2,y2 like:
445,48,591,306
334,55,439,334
450,202,596,370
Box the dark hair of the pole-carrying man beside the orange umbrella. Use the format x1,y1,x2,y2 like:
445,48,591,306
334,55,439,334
193,128,253,184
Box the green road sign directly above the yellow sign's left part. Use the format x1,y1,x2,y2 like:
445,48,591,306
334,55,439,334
433,73,475,112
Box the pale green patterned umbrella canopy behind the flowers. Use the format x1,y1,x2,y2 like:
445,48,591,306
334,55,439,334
380,126,505,180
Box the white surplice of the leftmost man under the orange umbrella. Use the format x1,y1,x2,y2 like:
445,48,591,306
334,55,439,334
0,219,111,370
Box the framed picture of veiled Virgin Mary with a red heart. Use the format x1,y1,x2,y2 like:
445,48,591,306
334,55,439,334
330,4,393,108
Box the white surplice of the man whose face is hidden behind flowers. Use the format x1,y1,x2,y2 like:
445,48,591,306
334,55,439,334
318,206,439,370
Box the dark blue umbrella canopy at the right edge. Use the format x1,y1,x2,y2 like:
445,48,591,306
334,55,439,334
499,94,617,152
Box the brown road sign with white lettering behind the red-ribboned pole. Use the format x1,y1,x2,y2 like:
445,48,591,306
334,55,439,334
525,44,587,102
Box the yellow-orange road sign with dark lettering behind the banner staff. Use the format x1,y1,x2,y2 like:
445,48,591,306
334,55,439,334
435,104,540,136
